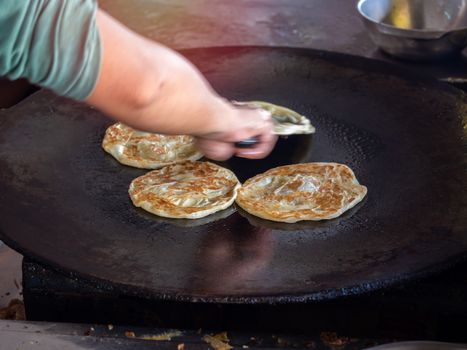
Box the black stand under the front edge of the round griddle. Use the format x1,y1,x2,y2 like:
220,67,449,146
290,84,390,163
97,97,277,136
23,258,467,342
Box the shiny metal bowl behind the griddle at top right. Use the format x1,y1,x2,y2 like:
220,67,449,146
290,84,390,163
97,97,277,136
357,0,467,60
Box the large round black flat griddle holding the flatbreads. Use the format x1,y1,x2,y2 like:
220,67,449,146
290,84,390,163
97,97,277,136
0,47,467,303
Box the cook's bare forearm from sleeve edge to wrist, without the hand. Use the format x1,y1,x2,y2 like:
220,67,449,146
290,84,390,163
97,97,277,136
88,11,231,135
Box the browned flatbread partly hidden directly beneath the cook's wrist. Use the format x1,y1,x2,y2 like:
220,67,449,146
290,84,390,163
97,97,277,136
102,123,203,169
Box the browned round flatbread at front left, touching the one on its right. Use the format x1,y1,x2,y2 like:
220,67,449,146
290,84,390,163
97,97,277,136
128,161,240,219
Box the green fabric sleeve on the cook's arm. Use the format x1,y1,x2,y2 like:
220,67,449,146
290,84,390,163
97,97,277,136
0,0,101,100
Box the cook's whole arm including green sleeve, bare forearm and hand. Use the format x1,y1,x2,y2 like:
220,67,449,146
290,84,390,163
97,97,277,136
0,0,275,159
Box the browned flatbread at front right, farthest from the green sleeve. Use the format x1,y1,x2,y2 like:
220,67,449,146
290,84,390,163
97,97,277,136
236,163,367,223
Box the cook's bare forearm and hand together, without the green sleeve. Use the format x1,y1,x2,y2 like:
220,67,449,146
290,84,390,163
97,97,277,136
87,11,276,159
